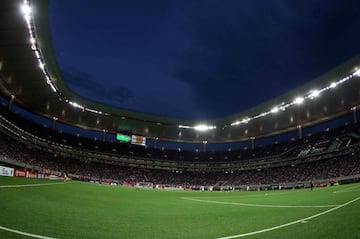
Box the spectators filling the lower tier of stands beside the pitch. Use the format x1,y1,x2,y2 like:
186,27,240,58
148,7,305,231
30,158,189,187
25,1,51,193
0,134,360,188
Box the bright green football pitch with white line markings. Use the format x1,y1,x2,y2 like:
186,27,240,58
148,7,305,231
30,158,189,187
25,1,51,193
0,177,360,239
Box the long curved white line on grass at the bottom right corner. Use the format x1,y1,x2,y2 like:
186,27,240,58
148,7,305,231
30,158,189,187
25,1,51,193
216,197,360,239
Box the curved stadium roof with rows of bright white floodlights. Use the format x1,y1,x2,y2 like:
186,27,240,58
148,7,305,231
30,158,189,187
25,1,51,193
0,0,360,143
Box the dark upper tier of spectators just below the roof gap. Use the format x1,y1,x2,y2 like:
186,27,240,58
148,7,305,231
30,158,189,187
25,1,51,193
0,103,360,162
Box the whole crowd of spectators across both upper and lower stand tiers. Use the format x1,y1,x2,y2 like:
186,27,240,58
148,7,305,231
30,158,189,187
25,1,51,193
0,105,360,188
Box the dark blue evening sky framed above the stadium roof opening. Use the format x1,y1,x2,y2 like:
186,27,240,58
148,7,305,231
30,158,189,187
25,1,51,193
49,0,360,119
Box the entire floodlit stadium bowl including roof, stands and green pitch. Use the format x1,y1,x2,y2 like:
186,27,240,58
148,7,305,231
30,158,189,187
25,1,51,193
0,0,360,239
